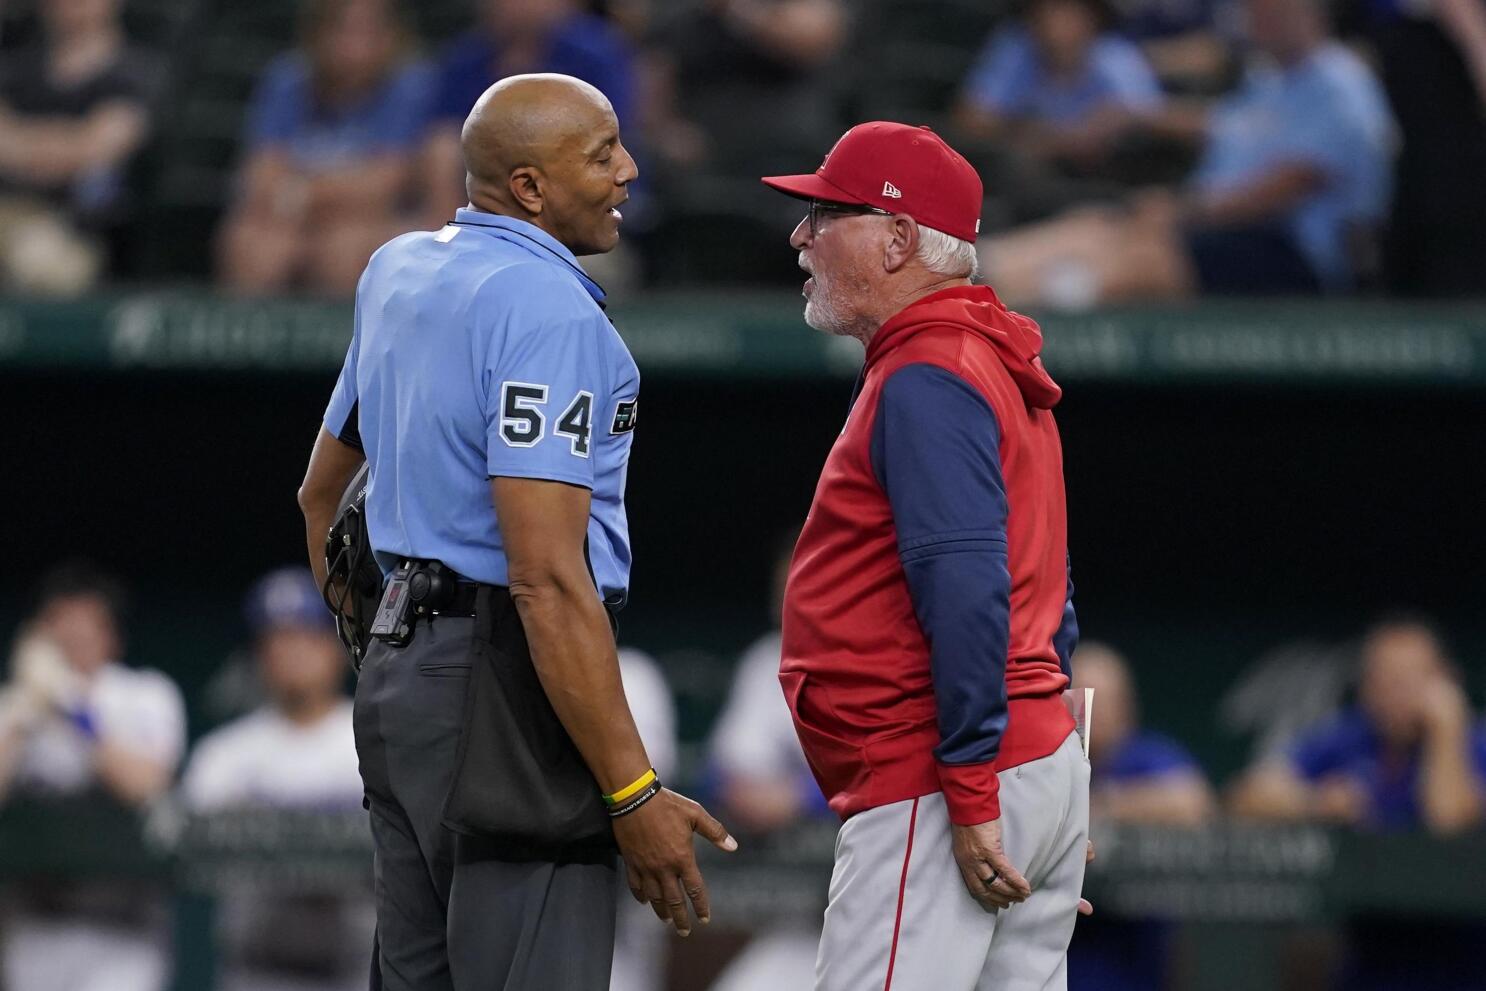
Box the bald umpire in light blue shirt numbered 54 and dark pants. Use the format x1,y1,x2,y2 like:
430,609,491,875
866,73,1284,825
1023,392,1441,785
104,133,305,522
299,74,736,991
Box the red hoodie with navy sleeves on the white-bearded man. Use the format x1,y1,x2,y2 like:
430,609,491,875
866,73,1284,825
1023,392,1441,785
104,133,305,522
780,287,1077,825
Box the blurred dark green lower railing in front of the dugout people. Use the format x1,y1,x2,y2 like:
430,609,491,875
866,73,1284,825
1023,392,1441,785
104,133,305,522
0,801,1486,991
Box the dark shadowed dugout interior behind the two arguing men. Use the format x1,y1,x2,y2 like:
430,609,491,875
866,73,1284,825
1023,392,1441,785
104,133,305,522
0,364,1486,777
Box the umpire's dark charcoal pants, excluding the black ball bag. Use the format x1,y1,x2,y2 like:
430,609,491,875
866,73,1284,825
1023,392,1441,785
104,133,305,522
355,618,618,991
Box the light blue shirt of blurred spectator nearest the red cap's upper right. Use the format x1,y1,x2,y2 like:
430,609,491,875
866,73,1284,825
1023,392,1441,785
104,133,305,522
964,28,1162,126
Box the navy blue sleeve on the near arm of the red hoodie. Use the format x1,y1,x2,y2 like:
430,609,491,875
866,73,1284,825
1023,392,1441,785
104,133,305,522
871,364,1010,765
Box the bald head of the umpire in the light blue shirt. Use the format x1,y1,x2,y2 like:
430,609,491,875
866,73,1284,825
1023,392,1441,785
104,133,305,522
461,73,639,254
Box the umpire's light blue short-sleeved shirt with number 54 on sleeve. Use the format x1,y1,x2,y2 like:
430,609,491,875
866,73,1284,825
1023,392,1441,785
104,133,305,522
325,208,639,608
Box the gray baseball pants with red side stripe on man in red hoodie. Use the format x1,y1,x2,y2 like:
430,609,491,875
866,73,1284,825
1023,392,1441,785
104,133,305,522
816,732,1089,991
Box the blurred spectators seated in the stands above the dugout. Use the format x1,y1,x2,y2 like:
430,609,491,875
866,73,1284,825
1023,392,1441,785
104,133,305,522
0,0,1486,308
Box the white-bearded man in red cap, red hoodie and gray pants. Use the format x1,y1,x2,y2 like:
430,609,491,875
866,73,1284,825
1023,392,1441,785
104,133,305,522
764,122,1089,991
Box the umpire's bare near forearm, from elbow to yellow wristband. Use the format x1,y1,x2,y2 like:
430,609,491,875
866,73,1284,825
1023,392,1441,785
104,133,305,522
510,568,651,793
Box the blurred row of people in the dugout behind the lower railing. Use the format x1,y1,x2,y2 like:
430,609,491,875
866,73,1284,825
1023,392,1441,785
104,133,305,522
0,541,1486,991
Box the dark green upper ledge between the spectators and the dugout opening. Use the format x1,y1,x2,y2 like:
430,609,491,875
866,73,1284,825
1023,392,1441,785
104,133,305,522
0,291,1486,386
